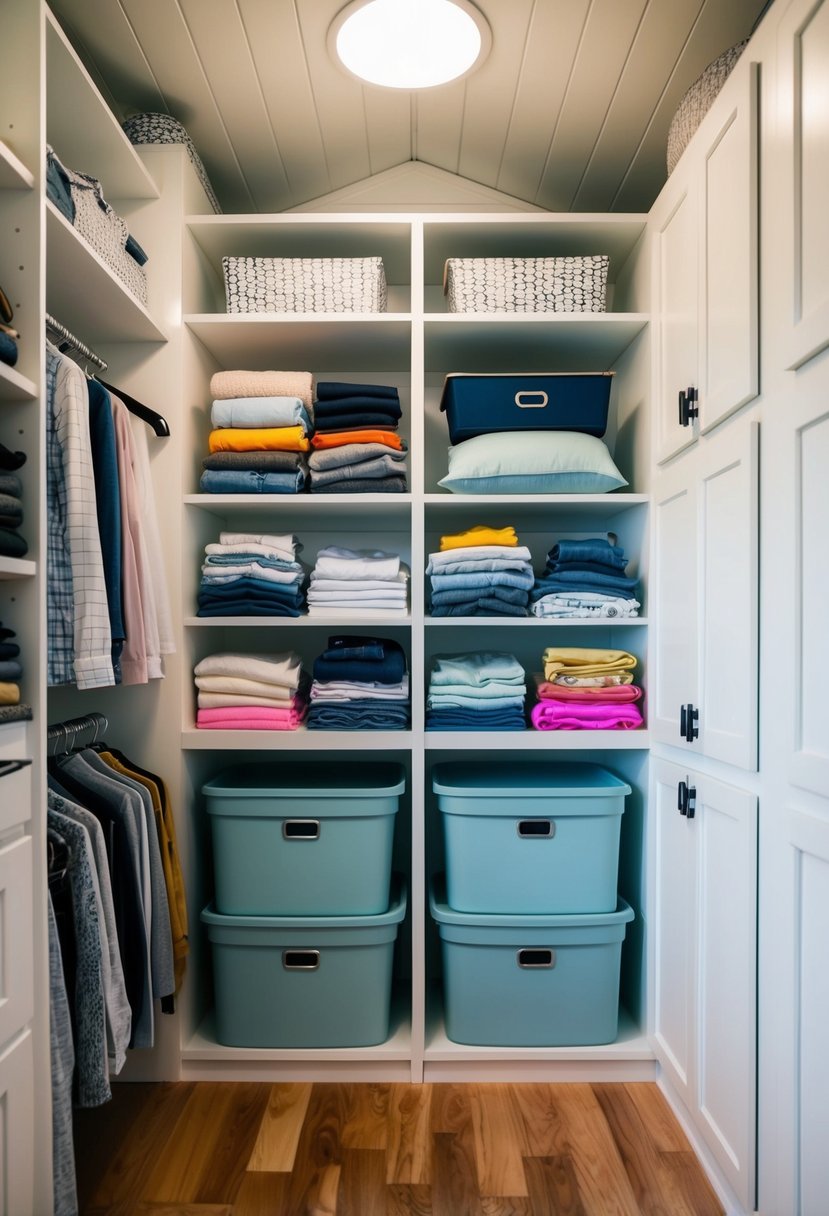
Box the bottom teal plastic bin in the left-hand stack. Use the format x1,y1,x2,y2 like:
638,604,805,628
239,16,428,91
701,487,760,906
202,883,406,1047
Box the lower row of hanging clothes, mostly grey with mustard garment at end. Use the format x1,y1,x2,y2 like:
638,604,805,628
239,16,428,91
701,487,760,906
46,711,187,1211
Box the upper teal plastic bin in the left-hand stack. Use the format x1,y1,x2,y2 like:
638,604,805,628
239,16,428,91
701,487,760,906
202,761,406,916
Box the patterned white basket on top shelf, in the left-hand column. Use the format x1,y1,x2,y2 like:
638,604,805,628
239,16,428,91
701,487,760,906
221,258,387,313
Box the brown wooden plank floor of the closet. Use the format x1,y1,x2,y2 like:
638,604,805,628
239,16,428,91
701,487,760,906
75,1082,722,1216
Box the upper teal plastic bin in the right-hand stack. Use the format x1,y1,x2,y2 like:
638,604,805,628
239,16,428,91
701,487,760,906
432,760,631,914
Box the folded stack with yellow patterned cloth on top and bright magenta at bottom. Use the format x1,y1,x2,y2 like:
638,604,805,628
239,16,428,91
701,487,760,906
530,647,643,731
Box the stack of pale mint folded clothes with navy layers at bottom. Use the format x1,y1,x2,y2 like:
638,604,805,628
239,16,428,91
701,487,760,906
425,652,526,731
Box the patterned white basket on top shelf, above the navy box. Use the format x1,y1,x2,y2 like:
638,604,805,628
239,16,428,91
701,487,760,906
444,254,609,313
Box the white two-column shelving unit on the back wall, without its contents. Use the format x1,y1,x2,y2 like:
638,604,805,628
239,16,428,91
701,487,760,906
180,206,654,1080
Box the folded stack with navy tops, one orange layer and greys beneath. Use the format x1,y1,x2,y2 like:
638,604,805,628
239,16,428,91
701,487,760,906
308,381,407,494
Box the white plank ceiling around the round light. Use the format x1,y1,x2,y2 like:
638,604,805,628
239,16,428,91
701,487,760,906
52,0,766,213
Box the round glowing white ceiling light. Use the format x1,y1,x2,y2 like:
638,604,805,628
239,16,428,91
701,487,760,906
328,0,491,89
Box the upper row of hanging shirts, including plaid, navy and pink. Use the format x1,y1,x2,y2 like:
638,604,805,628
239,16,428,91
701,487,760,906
46,315,175,688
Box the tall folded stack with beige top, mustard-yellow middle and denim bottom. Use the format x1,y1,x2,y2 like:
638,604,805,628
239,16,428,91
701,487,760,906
199,371,314,494
